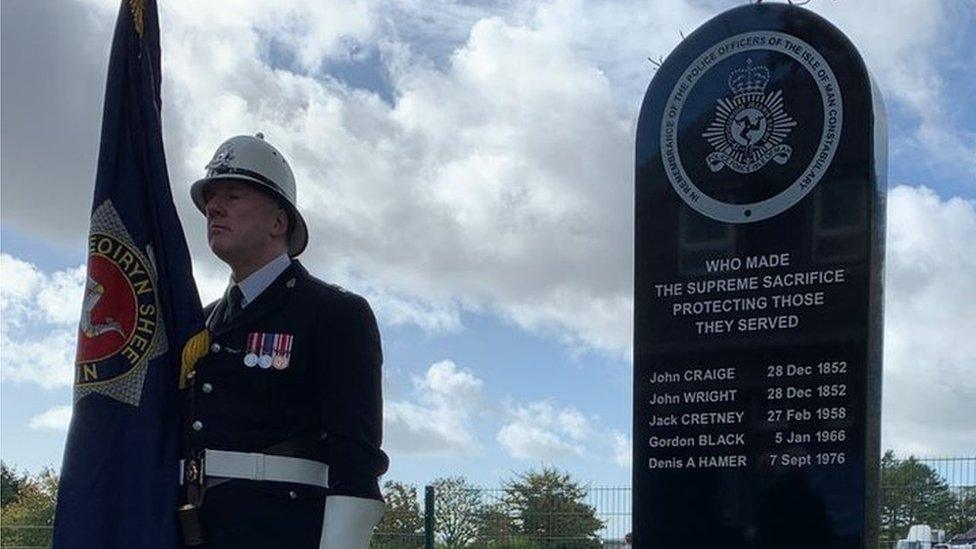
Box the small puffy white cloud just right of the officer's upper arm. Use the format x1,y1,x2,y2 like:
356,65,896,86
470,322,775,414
383,360,483,455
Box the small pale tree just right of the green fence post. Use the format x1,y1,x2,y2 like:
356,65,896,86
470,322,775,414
433,476,483,549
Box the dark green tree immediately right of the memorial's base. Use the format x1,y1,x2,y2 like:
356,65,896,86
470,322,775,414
881,450,957,541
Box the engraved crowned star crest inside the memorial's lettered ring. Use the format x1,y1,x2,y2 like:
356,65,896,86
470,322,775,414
702,59,796,173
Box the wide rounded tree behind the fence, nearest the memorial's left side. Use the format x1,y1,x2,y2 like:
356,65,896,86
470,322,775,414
505,468,603,549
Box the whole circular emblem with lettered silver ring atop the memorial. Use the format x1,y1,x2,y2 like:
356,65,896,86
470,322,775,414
658,30,844,223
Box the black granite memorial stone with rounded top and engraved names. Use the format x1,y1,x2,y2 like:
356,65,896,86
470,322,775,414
633,4,886,549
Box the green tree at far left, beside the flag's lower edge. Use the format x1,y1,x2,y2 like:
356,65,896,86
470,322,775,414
0,469,58,547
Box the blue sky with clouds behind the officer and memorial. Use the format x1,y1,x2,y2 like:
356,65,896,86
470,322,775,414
0,0,976,486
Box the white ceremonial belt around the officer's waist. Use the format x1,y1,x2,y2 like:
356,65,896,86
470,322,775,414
203,450,329,488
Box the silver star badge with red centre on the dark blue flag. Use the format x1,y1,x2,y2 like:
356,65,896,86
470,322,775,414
75,200,167,406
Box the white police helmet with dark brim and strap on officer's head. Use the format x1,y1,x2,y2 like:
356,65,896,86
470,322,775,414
190,133,308,257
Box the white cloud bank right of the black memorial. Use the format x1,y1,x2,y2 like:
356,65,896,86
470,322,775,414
882,186,976,455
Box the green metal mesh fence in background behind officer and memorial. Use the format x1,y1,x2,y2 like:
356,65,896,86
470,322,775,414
0,457,976,549
